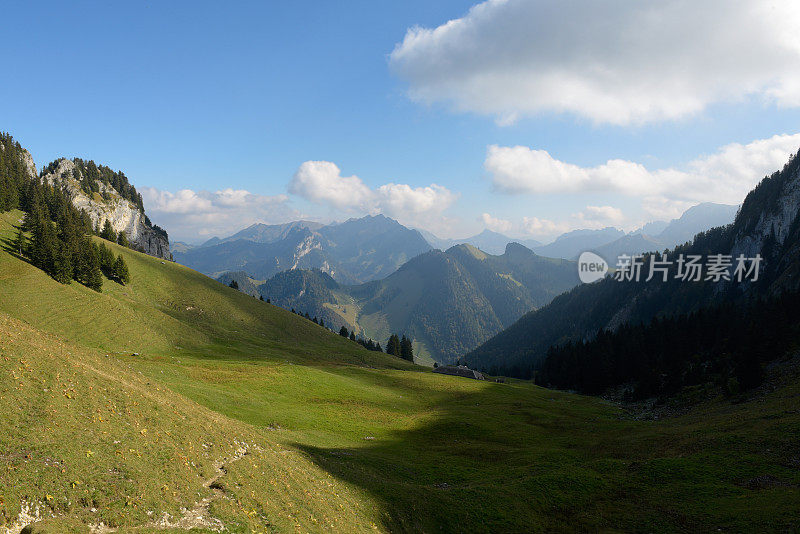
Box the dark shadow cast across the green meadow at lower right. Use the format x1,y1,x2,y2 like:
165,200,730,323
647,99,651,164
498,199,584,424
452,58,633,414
294,378,800,532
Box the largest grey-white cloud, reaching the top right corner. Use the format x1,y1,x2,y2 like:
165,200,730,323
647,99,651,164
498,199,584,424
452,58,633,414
390,0,800,125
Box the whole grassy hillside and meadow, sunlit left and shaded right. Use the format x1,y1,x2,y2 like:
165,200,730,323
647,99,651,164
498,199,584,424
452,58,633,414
0,212,800,532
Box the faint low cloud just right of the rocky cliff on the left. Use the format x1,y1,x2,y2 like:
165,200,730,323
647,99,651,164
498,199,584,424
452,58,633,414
139,187,301,242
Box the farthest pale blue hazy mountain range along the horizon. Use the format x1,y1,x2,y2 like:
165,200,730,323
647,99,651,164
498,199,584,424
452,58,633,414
178,203,737,285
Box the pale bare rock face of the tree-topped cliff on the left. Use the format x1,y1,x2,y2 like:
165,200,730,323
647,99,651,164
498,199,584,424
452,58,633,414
42,158,172,260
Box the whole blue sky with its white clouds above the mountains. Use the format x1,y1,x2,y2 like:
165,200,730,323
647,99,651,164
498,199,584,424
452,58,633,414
0,0,800,241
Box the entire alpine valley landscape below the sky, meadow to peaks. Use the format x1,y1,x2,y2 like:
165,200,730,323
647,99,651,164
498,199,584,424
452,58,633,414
0,130,800,534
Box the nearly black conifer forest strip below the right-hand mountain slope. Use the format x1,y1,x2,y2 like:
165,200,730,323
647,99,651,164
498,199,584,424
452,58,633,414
535,291,800,400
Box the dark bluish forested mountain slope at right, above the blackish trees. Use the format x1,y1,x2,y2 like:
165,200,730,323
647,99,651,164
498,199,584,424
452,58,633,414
464,151,800,376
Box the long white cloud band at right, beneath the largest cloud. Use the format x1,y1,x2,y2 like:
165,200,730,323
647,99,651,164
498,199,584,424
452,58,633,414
484,134,800,206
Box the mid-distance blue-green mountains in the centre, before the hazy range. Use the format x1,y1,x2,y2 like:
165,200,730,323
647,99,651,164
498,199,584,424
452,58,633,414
256,243,578,363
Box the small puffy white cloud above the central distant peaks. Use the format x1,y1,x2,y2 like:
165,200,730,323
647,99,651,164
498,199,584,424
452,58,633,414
289,161,458,227
